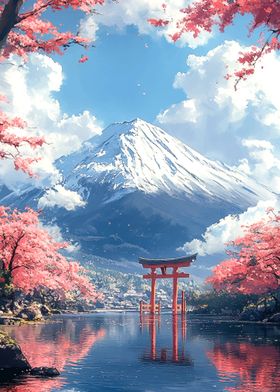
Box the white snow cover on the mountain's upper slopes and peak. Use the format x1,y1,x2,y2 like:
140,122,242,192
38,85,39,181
58,118,271,202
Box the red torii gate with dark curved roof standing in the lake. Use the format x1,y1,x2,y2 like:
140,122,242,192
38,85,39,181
139,254,197,314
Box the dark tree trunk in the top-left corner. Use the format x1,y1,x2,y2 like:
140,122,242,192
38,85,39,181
0,0,23,50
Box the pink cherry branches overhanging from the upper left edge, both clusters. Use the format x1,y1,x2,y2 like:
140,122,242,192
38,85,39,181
0,0,104,176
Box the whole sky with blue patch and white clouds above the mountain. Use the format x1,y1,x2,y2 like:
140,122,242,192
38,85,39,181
0,0,280,211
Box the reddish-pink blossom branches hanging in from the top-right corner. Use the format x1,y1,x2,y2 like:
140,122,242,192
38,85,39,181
149,0,280,83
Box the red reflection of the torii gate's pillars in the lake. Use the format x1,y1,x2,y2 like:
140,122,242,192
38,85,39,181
140,314,192,366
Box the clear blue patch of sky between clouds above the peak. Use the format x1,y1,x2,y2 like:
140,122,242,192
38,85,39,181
54,13,252,125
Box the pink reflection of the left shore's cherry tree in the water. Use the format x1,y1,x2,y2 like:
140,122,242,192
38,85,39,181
1,320,105,392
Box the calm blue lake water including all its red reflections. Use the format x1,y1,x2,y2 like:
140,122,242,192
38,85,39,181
0,313,280,392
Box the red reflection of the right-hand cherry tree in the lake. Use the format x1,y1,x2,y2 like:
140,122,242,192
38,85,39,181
207,342,280,392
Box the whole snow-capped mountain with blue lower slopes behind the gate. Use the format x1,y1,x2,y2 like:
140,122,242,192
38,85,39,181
1,119,273,261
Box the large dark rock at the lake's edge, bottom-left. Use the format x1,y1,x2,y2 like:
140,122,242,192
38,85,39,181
0,332,31,373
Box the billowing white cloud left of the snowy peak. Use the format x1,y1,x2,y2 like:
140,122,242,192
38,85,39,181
0,54,102,210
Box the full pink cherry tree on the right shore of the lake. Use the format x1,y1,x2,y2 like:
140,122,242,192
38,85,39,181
207,209,280,294
